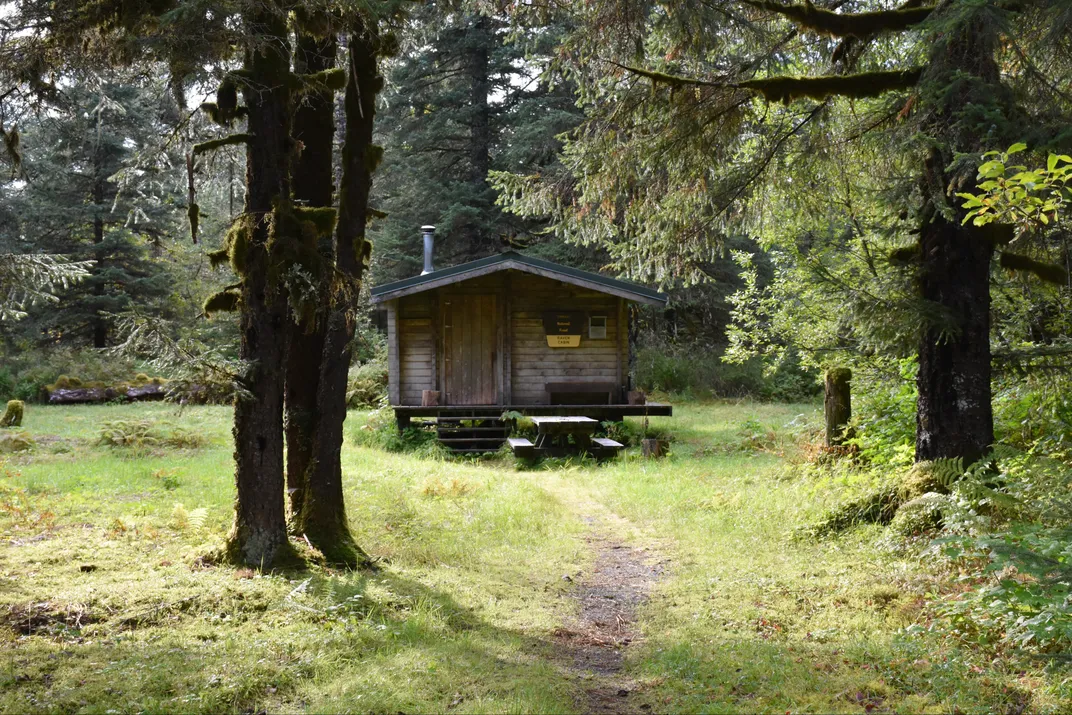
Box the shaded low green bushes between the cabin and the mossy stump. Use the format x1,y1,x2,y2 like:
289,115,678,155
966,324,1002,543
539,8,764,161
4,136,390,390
636,339,821,402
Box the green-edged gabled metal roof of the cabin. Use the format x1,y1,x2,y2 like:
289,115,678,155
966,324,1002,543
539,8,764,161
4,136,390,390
372,251,667,306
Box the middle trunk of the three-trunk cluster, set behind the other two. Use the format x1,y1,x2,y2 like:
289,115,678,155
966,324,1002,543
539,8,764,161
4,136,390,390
285,31,337,518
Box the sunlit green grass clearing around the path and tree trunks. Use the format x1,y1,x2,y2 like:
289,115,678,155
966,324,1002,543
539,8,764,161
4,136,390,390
0,403,1070,713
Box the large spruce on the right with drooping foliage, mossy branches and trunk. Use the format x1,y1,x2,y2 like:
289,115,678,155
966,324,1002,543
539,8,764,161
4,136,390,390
498,0,1072,460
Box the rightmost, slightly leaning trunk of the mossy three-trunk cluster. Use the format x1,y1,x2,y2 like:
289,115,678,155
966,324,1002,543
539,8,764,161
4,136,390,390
295,27,383,566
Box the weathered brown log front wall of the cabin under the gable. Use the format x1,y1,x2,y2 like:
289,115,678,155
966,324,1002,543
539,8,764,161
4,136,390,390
387,270,629,405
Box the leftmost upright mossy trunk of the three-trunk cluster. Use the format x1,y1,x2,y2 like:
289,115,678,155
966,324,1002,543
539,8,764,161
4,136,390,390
227,0,291,568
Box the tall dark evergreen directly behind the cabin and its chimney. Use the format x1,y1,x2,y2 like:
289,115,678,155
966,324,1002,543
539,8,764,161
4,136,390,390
373,5,590,282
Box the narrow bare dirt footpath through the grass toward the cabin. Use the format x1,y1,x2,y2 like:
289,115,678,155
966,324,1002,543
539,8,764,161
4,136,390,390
540,473,667,715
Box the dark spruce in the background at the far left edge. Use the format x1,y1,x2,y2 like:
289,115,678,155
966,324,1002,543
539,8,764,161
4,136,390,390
0,78,178,347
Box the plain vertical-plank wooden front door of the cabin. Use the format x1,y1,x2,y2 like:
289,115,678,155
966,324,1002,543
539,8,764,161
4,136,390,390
443,295,500,405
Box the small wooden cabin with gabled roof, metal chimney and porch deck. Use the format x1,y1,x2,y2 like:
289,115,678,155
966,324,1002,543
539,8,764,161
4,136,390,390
372,248,671,441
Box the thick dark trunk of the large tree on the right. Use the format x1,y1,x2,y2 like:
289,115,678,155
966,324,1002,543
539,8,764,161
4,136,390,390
915,15,1012,463
